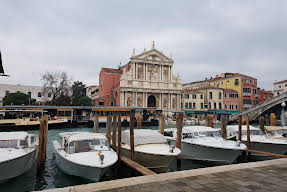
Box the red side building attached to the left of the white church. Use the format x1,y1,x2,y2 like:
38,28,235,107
94,68,122,107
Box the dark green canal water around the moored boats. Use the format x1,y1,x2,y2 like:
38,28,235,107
0,127,264,192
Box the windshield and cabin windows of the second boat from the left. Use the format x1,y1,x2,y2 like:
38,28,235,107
69,139,110,153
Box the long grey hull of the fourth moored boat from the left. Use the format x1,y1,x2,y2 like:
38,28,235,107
170,140,244,164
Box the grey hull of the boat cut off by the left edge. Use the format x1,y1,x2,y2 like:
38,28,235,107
0,147,38,183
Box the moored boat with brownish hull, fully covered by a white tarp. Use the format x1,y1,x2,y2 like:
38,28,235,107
122,129,180,173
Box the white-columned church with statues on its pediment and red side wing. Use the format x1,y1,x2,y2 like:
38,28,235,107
96,43,182,112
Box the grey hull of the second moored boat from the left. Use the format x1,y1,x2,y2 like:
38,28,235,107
55,145,111,181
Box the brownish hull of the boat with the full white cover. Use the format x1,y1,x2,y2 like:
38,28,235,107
121,148,176,173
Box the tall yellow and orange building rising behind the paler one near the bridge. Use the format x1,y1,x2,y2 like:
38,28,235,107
183,73,259,111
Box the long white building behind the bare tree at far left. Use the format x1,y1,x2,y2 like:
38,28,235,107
0,84,53,105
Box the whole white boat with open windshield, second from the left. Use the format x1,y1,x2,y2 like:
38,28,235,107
53,132,118,181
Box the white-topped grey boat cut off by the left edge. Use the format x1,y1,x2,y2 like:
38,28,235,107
0,132,38,183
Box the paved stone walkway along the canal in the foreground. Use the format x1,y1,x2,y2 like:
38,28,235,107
39,159,287,192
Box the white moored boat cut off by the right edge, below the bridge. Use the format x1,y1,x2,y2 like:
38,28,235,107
226,125,287,156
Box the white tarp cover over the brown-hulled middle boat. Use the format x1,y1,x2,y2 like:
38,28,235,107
122,129,167,146
